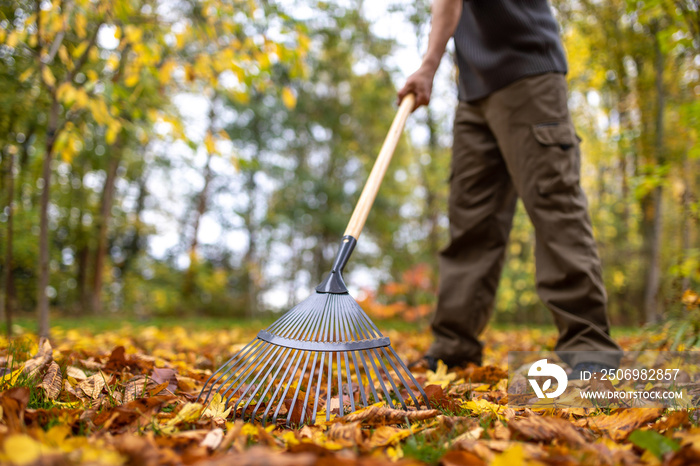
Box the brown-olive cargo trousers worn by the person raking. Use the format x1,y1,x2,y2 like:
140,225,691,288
428,73,620,366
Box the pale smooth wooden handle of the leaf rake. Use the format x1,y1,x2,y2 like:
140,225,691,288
344,94,416,239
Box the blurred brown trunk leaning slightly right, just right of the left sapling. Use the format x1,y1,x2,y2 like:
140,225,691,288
90,146,123,313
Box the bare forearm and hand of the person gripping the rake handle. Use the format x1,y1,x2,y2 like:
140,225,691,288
398,0,464,110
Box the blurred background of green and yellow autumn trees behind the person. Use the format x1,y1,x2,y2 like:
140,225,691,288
0,0,700,334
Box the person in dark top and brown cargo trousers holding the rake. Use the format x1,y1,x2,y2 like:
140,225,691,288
398,0,620,378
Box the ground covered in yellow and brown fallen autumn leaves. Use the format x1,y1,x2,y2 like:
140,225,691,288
0,326,700,466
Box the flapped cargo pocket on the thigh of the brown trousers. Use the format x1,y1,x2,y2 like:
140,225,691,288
532,121,581,195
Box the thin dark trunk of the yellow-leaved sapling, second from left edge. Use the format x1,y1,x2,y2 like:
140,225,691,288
37,95,60,338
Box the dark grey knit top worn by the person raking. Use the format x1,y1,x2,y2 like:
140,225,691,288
454,0,567,102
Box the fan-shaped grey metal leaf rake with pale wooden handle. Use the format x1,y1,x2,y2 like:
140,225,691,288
198,95,430,426
